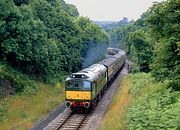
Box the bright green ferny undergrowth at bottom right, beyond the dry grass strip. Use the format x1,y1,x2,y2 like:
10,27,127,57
127,74,180,130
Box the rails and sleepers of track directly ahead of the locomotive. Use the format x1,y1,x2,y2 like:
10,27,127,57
43,109,91,130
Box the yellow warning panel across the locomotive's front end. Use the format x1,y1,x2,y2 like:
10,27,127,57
66,91,91,100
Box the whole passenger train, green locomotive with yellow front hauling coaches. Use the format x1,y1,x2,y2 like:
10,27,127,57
65,48,126,111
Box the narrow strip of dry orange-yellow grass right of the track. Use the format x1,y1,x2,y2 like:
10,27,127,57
101,77,131,130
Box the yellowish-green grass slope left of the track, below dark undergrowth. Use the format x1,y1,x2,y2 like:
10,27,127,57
0,83,64,130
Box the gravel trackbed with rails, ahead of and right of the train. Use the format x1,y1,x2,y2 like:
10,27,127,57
43,62,128,130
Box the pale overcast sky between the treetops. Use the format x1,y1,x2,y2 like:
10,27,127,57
65,0,163,21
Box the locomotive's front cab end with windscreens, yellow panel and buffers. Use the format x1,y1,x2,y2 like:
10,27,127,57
65,74,92,111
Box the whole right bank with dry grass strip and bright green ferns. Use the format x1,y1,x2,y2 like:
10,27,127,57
101,73,180,130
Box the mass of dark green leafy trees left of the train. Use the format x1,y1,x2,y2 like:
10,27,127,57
0,0,108,82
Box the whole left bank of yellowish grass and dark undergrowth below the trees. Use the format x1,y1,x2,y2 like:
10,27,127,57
0,64,64,130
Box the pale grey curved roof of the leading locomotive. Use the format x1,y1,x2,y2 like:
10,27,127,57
66,64,107,82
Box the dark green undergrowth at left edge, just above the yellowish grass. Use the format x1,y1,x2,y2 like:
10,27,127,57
0,63,38,97
